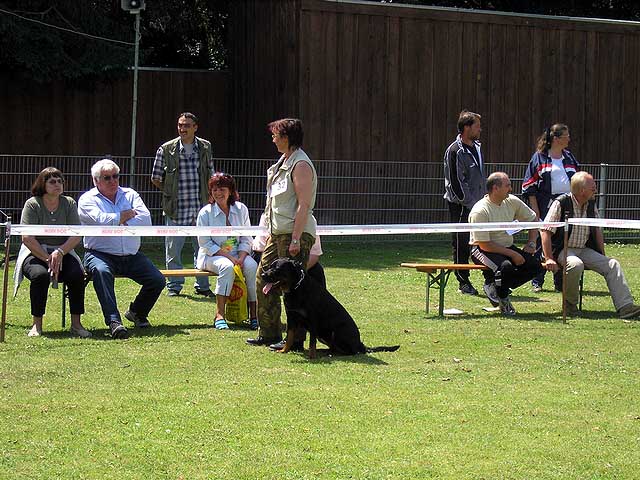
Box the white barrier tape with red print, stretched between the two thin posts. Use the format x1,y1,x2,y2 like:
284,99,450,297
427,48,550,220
11,222,564,237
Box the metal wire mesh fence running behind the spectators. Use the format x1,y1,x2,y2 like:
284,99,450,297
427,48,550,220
0,155,640,241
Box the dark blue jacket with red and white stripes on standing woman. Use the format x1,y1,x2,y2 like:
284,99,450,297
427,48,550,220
522,150,580,218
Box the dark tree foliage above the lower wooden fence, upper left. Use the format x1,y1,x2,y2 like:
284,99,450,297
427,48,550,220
0,0,228,82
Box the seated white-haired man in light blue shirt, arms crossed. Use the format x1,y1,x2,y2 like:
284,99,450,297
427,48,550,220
78,159,165,338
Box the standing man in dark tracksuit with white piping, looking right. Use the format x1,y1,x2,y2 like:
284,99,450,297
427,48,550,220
444,110,487,295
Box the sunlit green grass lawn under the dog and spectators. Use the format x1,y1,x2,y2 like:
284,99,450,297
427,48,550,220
0,242,640,479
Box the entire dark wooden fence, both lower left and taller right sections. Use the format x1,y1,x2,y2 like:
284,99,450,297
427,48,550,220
5,0,640,164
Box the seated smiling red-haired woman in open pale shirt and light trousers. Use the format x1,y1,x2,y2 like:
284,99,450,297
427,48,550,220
196,172,258,330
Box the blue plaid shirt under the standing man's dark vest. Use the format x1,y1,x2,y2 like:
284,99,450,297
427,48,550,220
151,140,214,225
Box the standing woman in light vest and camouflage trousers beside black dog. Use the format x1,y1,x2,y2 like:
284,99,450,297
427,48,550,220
247,118,318,346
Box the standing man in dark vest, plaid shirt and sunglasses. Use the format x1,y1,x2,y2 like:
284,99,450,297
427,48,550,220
151,112,215,297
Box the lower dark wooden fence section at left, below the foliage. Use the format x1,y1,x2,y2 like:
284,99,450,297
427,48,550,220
0,69,231,155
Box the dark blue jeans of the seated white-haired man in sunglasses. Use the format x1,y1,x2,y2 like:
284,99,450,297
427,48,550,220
84,250,164,325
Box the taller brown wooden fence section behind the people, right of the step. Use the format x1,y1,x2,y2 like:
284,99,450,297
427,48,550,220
231,0,640,164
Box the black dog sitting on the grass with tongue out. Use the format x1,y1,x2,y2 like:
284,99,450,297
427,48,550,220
262,258,400,358
